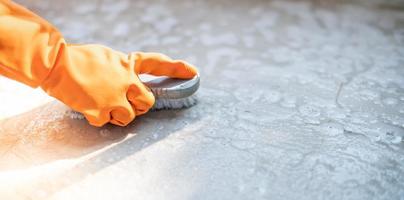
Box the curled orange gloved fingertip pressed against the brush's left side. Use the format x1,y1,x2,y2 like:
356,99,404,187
126,83,155,115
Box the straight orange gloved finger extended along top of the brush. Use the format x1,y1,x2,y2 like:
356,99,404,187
135,53,197,79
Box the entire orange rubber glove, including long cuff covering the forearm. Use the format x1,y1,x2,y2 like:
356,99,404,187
0,0,197,126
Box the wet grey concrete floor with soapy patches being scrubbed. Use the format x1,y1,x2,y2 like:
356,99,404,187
0,0,404,200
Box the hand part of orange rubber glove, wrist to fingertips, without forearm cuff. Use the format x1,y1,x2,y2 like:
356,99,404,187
41,48,196,126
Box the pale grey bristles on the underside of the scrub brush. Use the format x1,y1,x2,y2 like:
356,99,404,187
152,95,197,110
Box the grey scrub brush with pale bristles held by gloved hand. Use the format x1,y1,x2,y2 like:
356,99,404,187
139,74,199,111
